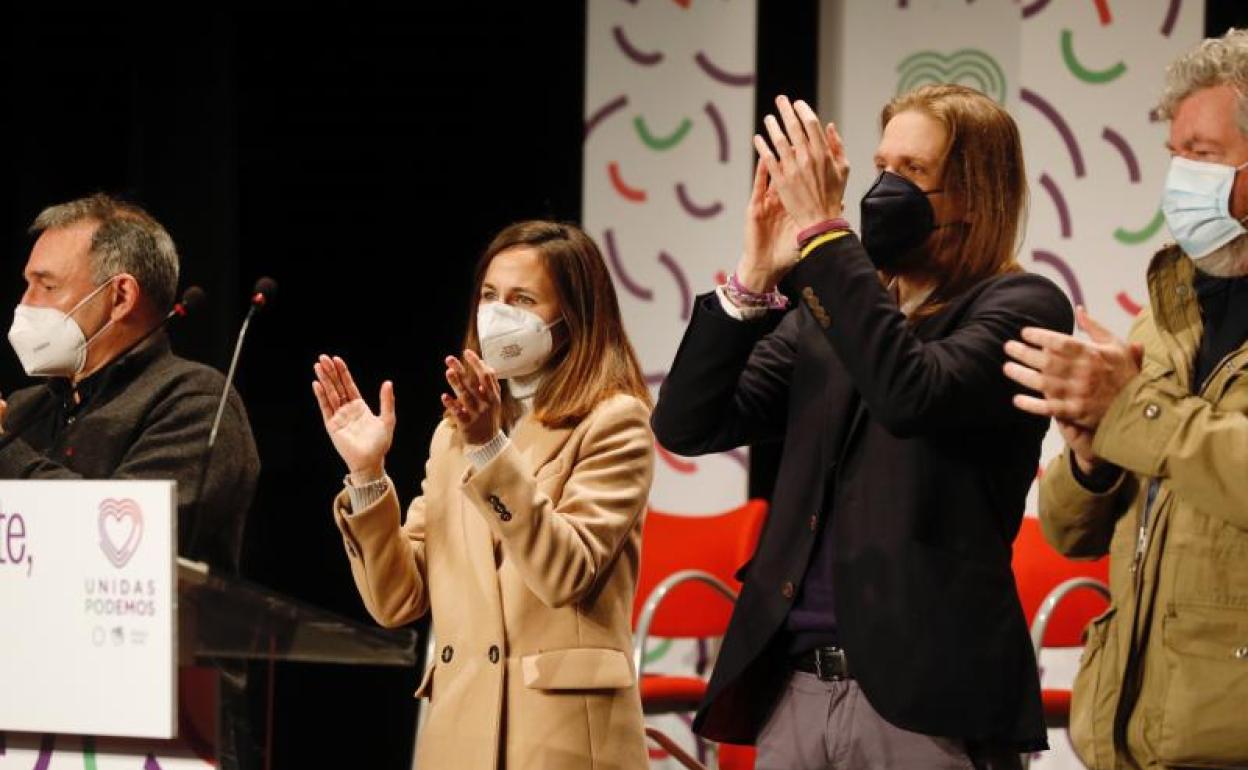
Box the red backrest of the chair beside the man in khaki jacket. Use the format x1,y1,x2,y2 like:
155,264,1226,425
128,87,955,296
1013,517,1109,646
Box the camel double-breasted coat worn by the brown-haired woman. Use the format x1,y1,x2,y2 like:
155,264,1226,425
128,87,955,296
333,396,654,770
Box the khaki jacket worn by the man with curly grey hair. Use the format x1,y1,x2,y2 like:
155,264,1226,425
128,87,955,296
1040,247,1248,770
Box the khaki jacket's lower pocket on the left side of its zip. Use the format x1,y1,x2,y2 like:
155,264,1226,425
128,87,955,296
1070,607,1122,770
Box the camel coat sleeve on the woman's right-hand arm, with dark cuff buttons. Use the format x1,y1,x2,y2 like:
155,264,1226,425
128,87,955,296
463,396,654,607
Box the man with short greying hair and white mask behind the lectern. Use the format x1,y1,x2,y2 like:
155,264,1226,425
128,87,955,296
0,195,260,570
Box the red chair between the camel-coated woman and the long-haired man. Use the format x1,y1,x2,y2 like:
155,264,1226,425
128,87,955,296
633,500,768,770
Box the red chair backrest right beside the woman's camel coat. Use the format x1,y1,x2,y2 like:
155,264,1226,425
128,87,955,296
633,500,768,638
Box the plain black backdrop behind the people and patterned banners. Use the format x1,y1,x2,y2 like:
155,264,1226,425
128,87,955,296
0,0,1248,768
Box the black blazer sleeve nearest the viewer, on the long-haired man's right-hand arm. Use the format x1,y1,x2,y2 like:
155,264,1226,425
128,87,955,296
791,235,1075,437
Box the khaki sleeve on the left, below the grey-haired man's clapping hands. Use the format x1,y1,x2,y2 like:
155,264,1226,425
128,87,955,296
1040,449,1138,559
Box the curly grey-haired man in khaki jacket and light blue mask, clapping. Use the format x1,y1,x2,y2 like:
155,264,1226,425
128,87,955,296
1006,30,1248,770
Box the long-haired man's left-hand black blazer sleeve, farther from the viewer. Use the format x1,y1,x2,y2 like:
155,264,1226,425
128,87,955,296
651,293,796,457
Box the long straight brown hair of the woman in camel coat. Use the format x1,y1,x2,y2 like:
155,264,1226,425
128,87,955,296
464,220,651,428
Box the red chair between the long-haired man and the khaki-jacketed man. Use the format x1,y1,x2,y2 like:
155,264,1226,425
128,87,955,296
1013,517,1109,766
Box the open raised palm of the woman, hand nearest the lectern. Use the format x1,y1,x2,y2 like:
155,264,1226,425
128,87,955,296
312,354,394,483
